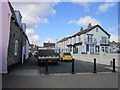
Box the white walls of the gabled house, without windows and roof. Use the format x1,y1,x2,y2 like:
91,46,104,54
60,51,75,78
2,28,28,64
56,27,109,52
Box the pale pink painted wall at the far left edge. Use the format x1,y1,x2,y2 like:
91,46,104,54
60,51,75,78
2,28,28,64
0,0,11,73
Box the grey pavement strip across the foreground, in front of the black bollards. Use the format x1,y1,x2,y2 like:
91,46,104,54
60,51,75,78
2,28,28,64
3,73,118,88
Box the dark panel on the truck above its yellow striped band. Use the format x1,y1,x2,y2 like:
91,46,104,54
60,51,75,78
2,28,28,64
38,50,59,56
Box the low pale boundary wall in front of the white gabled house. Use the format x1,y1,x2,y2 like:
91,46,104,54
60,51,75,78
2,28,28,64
73,53,120,67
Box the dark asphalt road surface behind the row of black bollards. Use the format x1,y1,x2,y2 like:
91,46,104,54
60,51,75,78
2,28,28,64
6,57,112,76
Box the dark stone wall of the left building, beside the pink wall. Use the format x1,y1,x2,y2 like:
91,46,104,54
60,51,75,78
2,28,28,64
7,19,23,66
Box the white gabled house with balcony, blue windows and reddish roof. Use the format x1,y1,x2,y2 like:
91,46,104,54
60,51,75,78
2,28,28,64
55,23,110,54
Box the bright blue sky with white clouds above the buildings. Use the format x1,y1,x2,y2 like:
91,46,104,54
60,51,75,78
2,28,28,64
12,0,118,45
